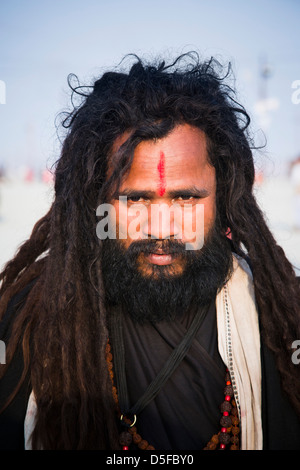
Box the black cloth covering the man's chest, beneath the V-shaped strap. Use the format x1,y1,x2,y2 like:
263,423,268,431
118,288,226,451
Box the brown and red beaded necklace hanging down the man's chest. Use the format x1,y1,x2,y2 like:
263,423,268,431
106,341,240,450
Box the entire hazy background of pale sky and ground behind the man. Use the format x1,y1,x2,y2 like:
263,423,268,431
0,0,300,272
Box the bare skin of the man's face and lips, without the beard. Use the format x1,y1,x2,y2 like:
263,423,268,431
112,124,216,275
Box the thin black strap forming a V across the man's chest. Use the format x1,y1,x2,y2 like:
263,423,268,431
111,304,210,424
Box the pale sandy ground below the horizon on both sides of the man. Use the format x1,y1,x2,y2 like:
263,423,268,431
0,177,300,274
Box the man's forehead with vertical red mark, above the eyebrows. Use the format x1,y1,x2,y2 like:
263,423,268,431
121,124,215,195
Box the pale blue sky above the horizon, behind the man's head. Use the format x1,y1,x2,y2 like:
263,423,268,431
0,0,300,174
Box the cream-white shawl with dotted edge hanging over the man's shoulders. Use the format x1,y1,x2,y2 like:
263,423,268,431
24,255,262,450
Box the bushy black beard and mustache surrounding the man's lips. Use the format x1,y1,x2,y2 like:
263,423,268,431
102,228,232,323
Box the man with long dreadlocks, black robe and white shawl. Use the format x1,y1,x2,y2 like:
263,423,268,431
0,54,300,450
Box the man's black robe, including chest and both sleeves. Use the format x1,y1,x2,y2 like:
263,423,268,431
0,283,300,451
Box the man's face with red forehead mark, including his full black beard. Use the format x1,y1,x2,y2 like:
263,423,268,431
101,125,232,323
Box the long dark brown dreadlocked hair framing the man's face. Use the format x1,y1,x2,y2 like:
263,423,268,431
0,53,300,449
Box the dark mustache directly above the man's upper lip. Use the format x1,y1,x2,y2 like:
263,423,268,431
127,239,187,257
